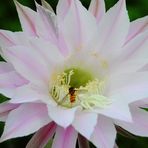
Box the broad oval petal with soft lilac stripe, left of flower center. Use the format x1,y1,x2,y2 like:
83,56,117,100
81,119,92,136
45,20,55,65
4,46,49,84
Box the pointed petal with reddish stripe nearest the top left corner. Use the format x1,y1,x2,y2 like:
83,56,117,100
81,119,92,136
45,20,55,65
14,0,37,36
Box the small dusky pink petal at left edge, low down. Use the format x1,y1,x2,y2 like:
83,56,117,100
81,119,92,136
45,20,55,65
0,101,20,121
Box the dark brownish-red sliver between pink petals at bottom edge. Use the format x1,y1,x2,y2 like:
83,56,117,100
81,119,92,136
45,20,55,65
78,134,89,148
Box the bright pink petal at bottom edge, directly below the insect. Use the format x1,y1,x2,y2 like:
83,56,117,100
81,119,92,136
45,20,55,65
52,126,77,148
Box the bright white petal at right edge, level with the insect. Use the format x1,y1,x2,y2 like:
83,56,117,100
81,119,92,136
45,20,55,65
110,72,148,104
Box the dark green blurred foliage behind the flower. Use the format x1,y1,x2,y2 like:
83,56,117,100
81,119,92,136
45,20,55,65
0,0,148,148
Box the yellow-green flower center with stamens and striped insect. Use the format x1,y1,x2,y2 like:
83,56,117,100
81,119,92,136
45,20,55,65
50,68,111,109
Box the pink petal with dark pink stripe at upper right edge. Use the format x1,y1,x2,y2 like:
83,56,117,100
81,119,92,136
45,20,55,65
125,16,148,44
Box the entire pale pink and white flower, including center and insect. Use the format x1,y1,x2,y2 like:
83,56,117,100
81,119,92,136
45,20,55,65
0,0,148,148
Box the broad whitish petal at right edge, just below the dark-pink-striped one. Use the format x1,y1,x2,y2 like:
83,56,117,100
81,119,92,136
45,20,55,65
114,31,148,73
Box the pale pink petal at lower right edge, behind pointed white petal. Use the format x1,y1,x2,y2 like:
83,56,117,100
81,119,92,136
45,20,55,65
115,103,148,137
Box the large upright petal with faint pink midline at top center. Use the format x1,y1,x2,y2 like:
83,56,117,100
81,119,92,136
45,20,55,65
59,0,97,51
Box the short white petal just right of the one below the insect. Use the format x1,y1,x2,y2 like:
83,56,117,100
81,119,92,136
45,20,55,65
72,111,97,139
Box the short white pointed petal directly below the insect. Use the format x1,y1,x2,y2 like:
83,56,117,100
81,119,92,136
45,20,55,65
47,105,77,128
